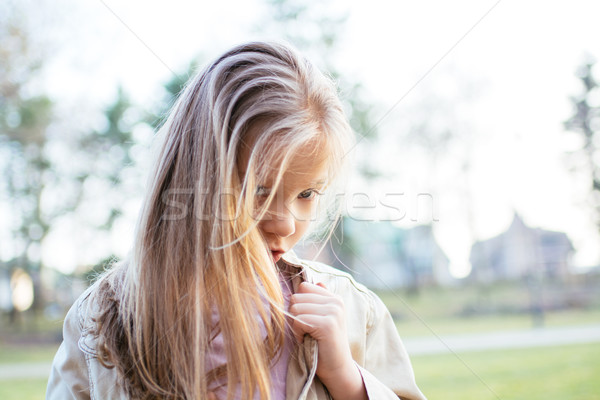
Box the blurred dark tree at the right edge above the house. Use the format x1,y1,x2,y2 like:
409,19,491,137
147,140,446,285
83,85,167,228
564,57,600,229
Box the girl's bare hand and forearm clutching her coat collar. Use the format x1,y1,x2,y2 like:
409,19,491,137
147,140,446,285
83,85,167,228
290,282,366,399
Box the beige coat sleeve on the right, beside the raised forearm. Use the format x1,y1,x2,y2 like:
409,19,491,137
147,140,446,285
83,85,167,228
358,291,425,400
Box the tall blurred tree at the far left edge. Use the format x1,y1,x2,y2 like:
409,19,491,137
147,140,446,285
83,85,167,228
0,2,53,314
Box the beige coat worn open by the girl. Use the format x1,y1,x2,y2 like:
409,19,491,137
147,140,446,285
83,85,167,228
46,251,425,400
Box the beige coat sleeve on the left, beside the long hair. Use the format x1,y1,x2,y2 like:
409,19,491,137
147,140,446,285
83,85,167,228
46,299,90,400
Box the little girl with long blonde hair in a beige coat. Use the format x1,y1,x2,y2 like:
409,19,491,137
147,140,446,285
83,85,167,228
47,43,424,400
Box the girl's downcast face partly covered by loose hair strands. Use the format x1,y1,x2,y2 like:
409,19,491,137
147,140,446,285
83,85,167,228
256,148,327,262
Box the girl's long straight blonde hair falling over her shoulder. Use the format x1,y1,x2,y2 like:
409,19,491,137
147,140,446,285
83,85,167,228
96,42,353,399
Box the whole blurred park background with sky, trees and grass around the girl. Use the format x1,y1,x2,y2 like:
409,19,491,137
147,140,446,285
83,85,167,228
0,0,600,399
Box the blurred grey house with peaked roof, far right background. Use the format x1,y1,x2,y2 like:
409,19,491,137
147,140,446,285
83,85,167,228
470,213,574,282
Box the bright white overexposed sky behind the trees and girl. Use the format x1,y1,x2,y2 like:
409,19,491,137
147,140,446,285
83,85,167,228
0,0,600,275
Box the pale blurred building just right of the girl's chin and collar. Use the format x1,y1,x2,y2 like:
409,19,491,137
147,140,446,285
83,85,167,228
296,218,454,288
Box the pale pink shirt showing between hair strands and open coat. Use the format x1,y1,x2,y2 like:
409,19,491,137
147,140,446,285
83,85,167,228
206,273,293,400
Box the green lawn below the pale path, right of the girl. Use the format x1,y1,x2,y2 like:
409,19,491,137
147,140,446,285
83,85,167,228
412,343,600,400
